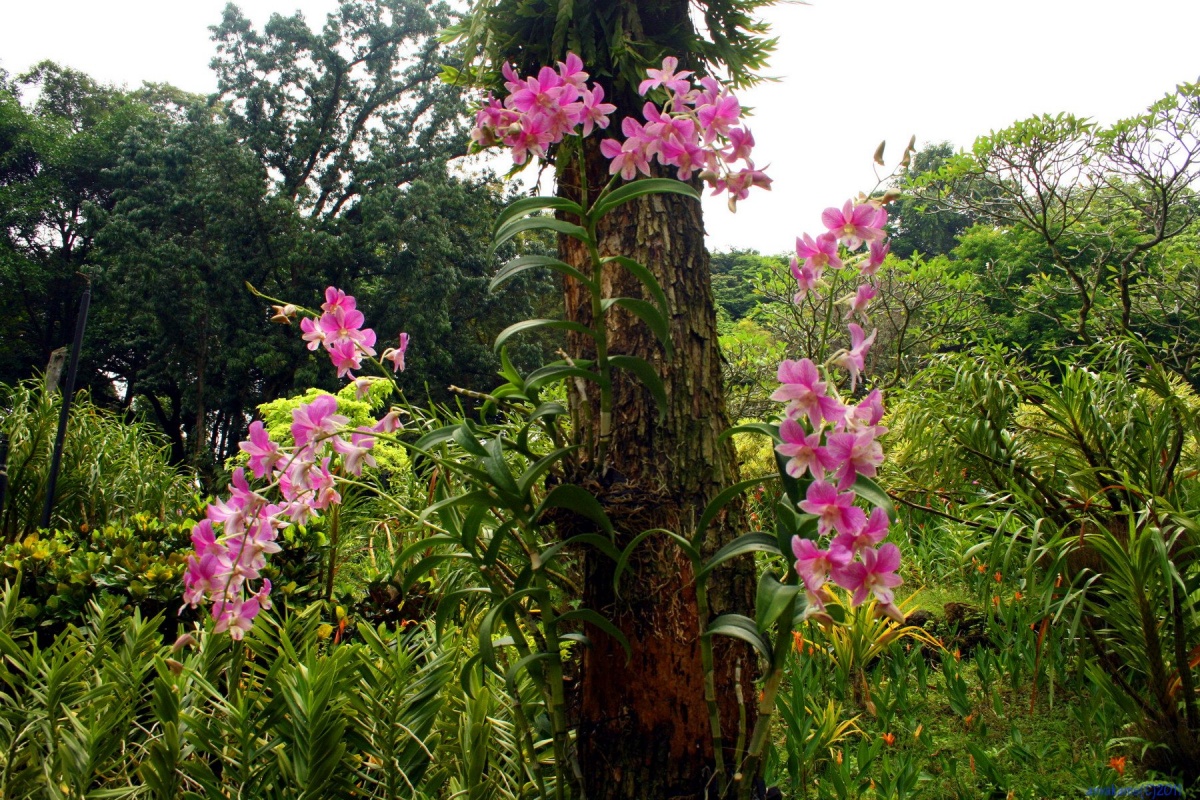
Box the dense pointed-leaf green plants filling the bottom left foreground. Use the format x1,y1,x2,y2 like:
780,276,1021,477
0,588,482,800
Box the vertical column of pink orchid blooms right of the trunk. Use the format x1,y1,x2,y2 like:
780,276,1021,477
772,196,904,620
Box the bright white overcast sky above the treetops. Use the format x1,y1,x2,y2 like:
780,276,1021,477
0,0,1200,253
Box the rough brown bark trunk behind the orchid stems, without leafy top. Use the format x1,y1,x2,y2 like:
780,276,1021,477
559,138,756,800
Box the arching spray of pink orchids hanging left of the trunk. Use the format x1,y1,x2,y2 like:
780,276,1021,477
184,287,408,639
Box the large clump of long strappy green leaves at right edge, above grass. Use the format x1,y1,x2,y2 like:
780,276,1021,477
893,343,1200,766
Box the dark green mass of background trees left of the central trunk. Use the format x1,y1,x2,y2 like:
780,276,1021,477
0,0,554,470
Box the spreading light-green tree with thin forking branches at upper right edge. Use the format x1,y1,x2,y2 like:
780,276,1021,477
913,84,1200,386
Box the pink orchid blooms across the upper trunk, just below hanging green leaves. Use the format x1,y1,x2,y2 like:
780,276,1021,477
472,53,770,209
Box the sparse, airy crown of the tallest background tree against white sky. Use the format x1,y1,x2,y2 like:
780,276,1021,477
212,0,466,219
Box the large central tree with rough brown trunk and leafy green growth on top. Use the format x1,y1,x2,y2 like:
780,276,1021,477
458,0,773,798
